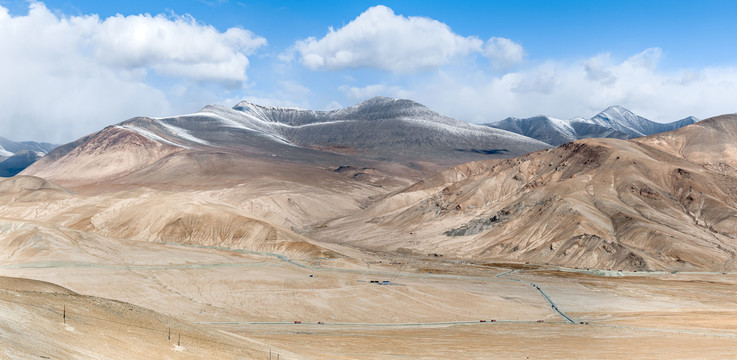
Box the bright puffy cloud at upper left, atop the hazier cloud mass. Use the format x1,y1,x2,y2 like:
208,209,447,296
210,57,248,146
91,14,266,85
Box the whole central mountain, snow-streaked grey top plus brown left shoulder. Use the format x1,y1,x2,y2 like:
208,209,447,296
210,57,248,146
25,97,549,185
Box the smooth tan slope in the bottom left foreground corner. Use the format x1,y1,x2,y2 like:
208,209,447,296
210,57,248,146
0,277,258,359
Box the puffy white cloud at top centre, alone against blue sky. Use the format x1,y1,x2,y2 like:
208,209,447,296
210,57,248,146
290,5,483,73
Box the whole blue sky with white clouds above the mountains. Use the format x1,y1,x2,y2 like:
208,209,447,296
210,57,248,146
0,0,737,143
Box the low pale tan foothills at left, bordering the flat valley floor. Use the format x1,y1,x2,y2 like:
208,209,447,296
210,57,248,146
0,176,342,258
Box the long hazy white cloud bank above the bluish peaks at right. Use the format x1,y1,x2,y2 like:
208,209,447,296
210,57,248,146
413,48,737,123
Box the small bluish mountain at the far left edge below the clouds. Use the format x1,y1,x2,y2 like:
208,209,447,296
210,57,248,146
0,137,57,177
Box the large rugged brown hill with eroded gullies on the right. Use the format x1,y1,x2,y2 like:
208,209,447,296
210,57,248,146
313,115,737,271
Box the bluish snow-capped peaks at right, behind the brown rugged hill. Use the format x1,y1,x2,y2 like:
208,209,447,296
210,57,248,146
485,106,698,146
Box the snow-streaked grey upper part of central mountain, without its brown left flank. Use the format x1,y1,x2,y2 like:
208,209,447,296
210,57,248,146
77,97,548,163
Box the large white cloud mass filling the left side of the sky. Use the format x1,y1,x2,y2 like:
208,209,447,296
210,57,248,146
0,2,266,142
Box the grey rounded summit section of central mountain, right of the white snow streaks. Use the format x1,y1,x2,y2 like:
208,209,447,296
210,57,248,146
217,97,545,160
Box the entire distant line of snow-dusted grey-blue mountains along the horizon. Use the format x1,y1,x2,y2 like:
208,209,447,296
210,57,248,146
5,97,695,176
